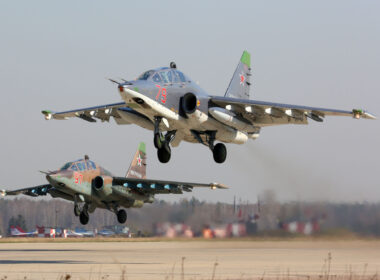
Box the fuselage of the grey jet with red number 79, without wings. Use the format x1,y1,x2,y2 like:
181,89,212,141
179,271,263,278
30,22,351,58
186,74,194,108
118,67,254,146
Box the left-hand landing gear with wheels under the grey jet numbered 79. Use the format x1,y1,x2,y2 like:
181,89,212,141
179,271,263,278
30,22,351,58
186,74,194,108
153,117,176,163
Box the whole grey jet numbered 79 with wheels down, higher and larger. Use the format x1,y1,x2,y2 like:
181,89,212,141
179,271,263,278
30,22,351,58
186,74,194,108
42,51,375,163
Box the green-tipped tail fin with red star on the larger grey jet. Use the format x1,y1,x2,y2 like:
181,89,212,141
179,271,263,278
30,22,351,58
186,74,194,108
224,51,251,99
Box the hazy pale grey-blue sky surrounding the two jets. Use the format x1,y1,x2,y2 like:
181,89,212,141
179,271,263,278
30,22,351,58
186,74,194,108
0,0,380,202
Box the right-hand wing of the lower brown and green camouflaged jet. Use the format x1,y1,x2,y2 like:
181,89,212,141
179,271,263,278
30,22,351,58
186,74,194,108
112,177,228,194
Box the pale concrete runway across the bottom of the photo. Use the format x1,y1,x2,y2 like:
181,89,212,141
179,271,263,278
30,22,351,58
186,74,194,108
0,240,380,280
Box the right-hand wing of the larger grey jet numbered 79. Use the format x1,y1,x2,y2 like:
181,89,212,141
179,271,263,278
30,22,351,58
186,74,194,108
209,96,376,127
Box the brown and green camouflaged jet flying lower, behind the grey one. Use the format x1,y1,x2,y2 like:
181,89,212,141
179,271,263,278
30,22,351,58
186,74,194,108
1,143,227,225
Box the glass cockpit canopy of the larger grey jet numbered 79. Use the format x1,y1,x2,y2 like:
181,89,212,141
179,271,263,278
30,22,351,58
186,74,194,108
137,67,189,84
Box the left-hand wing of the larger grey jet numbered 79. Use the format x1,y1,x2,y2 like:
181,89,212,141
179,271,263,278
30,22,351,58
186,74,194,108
42,102,126,122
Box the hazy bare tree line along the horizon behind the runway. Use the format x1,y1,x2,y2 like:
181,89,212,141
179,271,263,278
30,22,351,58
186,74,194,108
0,192,380,236
